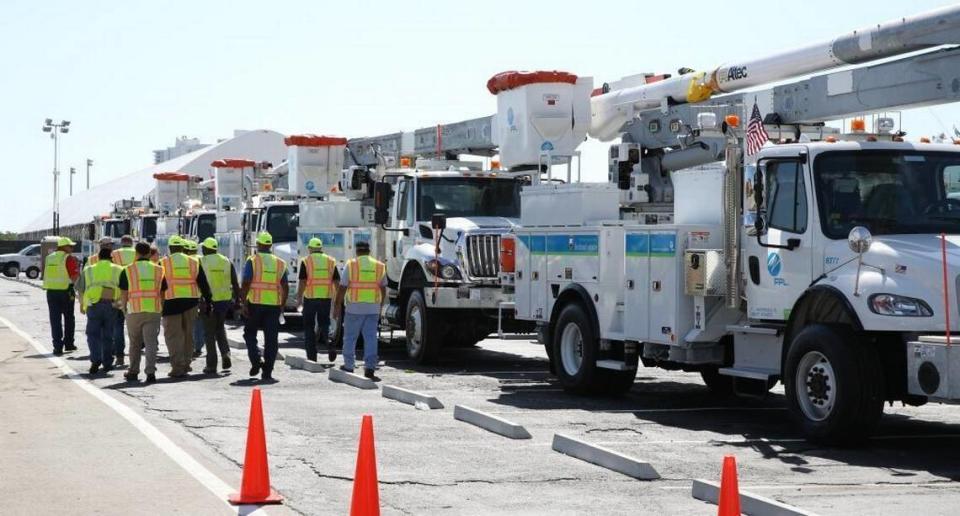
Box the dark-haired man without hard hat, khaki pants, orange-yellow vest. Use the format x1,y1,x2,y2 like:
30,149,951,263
119,242,163,383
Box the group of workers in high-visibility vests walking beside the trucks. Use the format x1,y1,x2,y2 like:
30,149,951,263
43,232,386,383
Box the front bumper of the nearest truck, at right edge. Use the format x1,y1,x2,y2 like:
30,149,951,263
907,336,960,401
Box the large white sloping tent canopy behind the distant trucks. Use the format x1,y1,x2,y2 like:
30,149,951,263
23,129,287,233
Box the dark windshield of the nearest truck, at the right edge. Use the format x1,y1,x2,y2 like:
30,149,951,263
814,150,960,239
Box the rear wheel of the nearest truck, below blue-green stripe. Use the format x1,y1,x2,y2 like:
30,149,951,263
553,303,602,394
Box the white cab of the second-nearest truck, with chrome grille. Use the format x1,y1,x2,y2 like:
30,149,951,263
381,166,533,361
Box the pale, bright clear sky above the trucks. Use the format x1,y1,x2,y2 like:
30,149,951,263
0,0,960,231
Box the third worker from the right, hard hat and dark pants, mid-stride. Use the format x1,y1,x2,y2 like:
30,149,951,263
241,231,290,381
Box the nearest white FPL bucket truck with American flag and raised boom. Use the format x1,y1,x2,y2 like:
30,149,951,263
506,7,960,443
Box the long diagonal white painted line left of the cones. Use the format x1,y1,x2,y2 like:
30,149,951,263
0,317,267,515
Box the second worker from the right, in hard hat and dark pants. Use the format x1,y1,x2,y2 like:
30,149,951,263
297,238,339,362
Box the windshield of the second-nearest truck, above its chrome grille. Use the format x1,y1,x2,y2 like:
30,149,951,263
418,177,523,220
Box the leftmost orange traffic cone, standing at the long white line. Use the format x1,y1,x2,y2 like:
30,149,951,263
227,387,283,505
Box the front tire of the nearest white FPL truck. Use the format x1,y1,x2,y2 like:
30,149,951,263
784,324,884,445
